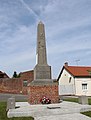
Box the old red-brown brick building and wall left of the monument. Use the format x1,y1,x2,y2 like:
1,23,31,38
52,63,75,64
0,70,34,94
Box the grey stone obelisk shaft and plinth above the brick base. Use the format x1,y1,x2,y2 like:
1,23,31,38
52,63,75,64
34,21,51,81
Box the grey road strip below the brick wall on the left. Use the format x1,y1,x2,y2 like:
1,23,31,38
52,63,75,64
0,93,27,101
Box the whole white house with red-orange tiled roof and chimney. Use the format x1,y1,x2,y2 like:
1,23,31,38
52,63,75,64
57,63,91,96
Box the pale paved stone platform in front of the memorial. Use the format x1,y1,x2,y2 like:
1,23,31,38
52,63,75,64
7,101,91,120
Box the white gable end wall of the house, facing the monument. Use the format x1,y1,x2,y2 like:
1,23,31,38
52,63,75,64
59,69,75,95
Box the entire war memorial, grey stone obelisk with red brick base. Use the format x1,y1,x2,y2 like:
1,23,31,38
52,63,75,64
28,21,59,104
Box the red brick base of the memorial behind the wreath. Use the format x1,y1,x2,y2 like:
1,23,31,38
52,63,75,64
28,84,59,104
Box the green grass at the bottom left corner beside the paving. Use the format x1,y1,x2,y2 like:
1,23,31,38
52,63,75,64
0,102,34,120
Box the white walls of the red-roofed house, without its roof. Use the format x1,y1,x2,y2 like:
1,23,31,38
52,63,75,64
59,69,91,96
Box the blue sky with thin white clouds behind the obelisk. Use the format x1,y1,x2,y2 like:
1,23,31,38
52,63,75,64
0,0,91,78
